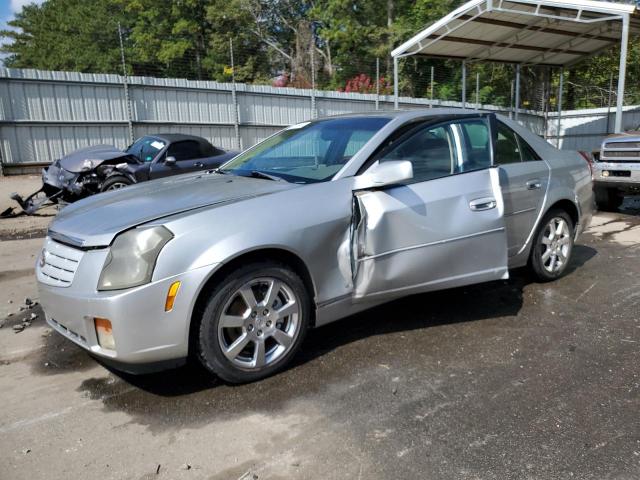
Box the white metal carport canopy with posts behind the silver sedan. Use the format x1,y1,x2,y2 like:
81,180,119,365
391,0,640,132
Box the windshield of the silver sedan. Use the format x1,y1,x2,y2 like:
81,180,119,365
220,117,389,183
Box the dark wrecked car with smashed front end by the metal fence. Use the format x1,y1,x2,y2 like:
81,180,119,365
6,133,237,214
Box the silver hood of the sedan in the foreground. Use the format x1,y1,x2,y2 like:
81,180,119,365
49,173,299,247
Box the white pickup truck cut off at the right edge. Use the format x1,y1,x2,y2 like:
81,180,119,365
593,127,640,210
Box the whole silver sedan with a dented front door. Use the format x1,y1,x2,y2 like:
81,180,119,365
36,109,593,382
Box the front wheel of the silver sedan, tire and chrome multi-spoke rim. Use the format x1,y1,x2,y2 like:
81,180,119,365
197,261,311,383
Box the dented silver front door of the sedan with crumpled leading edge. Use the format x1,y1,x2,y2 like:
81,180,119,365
352,116,508,299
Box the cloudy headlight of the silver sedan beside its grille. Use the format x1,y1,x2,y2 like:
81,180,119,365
98,227,173,290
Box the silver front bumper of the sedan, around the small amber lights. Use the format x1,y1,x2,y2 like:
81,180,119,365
38,249,213,364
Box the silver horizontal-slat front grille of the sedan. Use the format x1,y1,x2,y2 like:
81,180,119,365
37,238,84,287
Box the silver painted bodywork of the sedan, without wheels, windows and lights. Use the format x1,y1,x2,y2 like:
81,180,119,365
37,109,593,363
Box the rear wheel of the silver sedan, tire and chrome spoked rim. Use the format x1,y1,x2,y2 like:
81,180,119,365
529,209,575,282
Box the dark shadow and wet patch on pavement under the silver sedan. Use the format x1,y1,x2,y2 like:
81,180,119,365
66,246,596,430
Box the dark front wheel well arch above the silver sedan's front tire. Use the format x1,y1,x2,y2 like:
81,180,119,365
189,248,316,353
